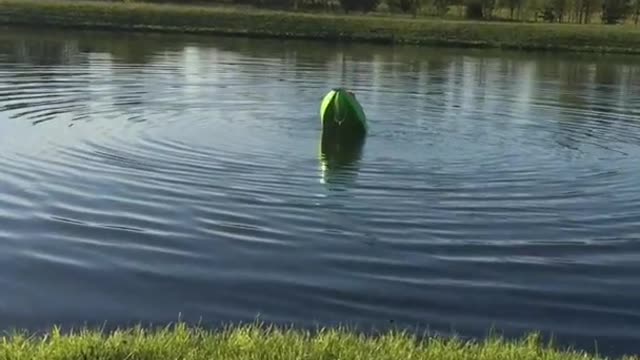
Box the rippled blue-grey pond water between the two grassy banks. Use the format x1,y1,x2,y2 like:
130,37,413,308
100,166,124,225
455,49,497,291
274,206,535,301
0,29,640,353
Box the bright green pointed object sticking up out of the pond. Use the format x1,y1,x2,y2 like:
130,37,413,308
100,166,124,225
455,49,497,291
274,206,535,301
320,88,368,137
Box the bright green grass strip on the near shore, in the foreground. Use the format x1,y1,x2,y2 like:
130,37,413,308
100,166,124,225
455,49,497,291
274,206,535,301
0,323,638,360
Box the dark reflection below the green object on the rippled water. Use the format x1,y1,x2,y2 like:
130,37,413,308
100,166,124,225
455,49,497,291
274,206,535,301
320,134,366,190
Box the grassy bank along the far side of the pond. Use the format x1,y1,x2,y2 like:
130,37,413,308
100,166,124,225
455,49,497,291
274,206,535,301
0,0,640,54
